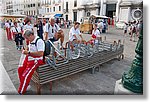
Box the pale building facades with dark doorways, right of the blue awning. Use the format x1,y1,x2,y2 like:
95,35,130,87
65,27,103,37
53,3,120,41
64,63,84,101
64,0,143,22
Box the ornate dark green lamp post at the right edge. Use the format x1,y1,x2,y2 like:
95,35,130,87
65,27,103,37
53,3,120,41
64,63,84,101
122,25,143,93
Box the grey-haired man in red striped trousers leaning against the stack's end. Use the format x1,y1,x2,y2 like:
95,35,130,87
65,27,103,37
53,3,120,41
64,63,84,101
18,30,45,95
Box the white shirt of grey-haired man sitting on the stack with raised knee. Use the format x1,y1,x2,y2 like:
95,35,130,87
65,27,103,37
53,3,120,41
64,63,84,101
44,23,61,39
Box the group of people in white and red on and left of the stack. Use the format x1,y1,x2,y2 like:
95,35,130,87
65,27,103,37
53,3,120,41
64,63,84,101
2,17,100,94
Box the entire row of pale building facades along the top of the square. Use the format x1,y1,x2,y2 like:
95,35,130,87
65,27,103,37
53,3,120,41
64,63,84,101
1,0,143,22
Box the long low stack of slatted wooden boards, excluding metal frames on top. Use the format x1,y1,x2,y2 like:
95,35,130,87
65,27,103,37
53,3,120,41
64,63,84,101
32,45,124,94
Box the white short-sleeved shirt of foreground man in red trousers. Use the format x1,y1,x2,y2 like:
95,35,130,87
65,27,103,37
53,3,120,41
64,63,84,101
28,36,45,61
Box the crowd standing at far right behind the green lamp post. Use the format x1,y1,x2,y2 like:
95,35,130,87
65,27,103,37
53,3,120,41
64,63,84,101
124,21,142,42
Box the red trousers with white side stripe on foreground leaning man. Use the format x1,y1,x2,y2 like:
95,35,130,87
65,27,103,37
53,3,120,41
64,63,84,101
18,56,44,94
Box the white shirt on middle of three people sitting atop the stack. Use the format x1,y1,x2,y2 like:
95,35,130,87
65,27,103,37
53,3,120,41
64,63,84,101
69,27,81,41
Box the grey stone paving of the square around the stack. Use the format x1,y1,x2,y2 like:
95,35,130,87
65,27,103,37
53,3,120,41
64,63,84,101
0,27,137,94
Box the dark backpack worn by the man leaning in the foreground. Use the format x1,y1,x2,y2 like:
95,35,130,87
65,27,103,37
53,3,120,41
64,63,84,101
31,38,51,56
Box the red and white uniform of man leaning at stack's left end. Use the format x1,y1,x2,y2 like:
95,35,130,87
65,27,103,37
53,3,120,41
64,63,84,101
18,37,45,94
